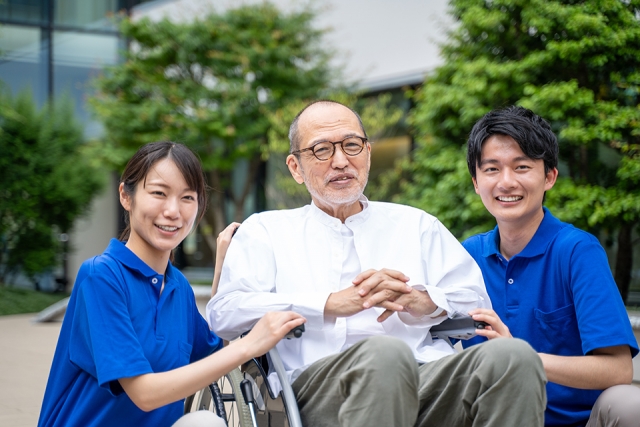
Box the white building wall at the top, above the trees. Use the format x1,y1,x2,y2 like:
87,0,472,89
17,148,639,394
133,0,452,88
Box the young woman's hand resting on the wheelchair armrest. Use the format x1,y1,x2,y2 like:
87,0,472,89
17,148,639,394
240,311,307,357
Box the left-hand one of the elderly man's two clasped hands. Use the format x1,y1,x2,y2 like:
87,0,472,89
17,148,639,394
324,269,412,317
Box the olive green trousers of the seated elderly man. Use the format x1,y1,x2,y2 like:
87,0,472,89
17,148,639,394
292,336,546,427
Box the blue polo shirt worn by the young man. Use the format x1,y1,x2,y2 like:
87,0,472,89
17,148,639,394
463,208,638,426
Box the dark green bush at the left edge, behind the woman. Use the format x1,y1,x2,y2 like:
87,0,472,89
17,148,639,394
0,91,104,283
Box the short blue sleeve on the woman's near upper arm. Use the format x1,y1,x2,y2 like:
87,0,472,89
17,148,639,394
69,264,153,394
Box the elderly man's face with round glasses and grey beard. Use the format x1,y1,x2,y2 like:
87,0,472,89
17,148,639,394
287,104,371,216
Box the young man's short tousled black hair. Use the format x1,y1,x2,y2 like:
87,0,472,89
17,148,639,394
467,106,558,178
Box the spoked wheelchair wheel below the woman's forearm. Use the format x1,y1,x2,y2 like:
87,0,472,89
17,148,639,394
184,368,253,427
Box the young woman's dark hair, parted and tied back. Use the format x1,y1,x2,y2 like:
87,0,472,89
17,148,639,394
120,141,207,241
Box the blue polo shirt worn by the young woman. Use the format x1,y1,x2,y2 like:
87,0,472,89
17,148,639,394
38,239,222,427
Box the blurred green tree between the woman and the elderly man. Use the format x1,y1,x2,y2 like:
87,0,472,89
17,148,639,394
91,2,334,251
